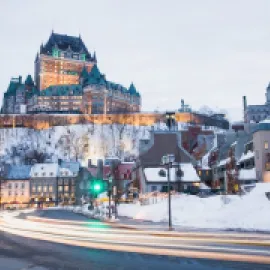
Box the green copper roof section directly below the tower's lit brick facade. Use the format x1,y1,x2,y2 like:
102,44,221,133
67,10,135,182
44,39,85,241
40,84,83,96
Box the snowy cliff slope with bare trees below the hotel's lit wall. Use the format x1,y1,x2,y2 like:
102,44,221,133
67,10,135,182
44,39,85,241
0,124,150,163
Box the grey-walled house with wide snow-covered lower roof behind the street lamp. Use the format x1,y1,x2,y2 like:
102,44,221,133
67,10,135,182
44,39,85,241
133,130,200,193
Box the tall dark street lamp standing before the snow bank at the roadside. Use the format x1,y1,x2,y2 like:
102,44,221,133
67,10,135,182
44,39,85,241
160,155,175,231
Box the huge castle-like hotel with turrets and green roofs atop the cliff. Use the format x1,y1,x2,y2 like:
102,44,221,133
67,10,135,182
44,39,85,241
1,33,141,114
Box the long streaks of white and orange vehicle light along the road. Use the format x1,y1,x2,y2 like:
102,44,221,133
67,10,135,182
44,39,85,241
0,214,270,264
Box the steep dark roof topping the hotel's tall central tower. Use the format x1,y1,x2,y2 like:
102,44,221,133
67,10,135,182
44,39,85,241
40,33,92,60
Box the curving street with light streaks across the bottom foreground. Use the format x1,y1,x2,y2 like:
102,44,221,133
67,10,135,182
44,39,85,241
0,210,270,270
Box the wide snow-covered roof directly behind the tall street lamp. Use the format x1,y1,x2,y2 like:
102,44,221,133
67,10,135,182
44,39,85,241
144,163,200,182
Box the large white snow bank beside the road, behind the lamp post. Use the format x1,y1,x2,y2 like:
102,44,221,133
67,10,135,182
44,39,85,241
118,184,270,231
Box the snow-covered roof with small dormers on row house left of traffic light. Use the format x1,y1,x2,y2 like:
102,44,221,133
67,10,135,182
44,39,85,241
30,163,59,178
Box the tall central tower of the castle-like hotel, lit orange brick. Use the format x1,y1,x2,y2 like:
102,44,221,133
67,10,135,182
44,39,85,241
35,32,97,91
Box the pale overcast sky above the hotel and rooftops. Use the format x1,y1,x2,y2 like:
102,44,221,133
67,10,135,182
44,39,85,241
0,0,270,120
